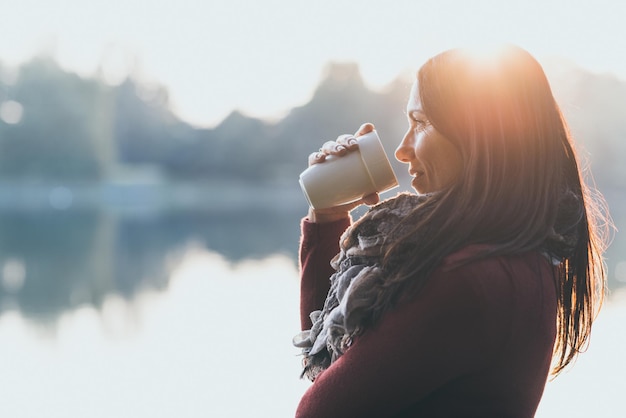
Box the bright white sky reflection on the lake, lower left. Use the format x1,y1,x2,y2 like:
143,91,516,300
0,248,307,418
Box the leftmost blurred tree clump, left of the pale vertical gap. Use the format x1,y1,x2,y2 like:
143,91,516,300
0,59,106,179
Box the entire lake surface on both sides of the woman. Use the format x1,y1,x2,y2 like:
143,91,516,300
0,211,626,418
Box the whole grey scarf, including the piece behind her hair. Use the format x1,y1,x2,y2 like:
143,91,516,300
293,190,584,381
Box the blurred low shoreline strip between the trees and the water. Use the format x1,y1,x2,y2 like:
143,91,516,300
0,181,307,212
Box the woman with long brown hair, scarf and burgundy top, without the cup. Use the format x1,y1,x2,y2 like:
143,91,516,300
294,46,605,417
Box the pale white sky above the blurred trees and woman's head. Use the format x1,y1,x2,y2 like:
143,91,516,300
0,0,626,127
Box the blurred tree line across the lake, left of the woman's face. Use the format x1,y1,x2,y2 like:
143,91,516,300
0,57,410,181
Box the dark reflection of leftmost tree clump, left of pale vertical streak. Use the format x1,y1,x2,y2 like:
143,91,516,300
0,212,102,320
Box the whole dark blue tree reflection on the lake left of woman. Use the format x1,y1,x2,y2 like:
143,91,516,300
0,211,302,324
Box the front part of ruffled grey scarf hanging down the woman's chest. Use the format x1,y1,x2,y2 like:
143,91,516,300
293,194,427,381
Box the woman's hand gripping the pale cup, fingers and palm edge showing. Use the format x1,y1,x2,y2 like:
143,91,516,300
308,123,380,223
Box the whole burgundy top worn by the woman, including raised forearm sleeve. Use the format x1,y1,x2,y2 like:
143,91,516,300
296,220,557,418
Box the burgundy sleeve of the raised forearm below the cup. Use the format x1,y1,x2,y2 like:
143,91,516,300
300,219,350,330
